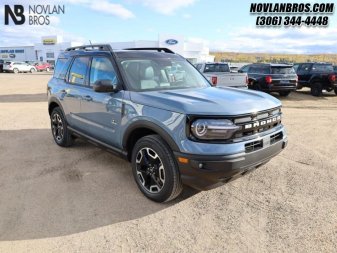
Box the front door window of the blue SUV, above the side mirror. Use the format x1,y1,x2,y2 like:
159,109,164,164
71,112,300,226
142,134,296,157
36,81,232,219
90,57,117,86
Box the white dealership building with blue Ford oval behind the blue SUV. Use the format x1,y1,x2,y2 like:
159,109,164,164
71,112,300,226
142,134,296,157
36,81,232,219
0,35,214,64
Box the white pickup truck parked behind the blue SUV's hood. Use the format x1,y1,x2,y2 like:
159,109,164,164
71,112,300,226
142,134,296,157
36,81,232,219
195,62,248,88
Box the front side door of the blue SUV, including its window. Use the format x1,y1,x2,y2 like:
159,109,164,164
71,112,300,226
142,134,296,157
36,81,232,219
80,56,124,147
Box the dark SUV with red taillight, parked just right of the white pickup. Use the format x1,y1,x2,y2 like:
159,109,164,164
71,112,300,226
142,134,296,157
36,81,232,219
238,63,297,97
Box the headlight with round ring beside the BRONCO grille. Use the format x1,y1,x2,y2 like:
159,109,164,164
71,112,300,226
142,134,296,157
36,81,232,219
191,119,240,140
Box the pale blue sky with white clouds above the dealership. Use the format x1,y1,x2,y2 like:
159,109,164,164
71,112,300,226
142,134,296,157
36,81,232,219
0,0,337,54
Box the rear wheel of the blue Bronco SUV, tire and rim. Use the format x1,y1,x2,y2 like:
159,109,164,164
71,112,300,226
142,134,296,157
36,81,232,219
50,107,74,147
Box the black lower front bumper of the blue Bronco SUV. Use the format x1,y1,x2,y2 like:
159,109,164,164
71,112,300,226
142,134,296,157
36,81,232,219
175,132,288,190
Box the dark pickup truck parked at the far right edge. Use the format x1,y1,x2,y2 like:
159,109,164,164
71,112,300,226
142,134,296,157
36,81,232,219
294,62,337,96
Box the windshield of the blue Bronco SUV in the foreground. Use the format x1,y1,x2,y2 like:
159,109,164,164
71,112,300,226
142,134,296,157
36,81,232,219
120,58,210,91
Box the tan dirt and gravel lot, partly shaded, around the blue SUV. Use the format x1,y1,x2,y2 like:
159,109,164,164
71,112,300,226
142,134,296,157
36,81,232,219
0,73,337,252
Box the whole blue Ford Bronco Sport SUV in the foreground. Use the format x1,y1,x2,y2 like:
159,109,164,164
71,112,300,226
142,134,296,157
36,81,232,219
48,45,287,202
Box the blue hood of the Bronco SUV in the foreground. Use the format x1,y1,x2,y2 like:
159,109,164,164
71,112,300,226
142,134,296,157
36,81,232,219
130,87,281,116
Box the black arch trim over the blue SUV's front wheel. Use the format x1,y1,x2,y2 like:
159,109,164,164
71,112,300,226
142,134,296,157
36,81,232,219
122,120,180,151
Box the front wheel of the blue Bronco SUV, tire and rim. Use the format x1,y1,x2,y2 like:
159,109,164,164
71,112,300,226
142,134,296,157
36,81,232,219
131,135,183,202
